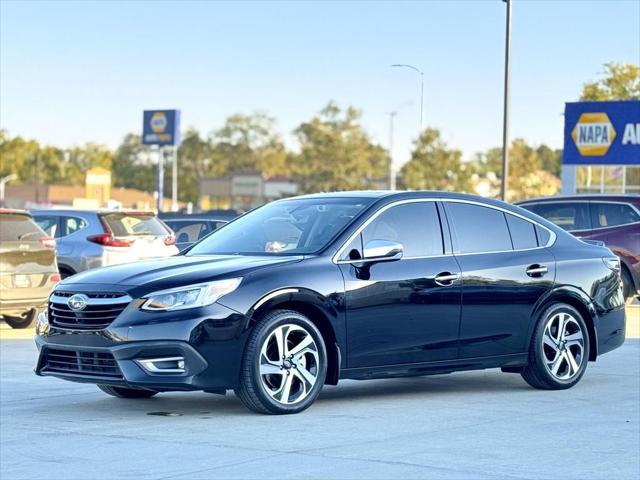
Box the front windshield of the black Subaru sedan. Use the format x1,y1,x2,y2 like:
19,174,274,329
187,198,371,255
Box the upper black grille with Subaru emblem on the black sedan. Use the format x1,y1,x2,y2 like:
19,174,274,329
48,292,131,330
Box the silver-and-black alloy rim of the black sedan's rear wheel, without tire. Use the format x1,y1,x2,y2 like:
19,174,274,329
542,312,585,381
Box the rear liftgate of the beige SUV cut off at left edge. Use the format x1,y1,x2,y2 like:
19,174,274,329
0,213,57,301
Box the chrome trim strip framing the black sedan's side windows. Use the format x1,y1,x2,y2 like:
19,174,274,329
331,198,557,265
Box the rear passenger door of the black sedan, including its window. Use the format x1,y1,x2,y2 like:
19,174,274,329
445,201,555,358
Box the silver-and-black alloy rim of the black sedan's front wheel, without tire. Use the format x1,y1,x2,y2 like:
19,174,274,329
259,323,320,405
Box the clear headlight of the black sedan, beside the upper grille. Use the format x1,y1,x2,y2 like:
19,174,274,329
140,278,242,311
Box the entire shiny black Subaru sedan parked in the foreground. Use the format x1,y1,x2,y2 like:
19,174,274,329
36,192,625,413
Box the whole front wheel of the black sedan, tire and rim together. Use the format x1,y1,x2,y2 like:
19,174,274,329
235,310,327,414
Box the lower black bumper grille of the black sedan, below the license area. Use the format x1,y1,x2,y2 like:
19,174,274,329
42,348,123,378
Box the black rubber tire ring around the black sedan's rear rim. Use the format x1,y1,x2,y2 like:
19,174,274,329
531,303,590,389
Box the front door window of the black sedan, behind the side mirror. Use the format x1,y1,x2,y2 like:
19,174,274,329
362,202,444,257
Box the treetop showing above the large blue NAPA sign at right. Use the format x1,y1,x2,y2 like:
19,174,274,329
580,62,640,101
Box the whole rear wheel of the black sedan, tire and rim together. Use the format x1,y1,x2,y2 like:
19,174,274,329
521,303,589,390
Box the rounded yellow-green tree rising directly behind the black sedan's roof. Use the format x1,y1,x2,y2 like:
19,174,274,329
289,102,389,193
